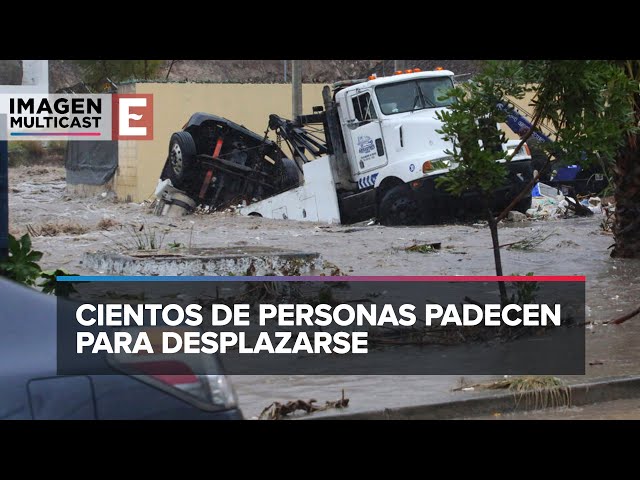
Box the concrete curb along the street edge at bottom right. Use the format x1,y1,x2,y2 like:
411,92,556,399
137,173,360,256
300,376,640,420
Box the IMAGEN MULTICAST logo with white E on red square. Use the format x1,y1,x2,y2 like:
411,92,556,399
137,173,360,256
0,94,153,141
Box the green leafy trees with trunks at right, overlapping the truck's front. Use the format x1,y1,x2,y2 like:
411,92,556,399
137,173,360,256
438,60,640,302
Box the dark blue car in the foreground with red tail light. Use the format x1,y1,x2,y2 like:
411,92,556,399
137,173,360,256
0,277,242,420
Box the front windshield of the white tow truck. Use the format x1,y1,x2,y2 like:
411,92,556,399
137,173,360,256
376,77,453,115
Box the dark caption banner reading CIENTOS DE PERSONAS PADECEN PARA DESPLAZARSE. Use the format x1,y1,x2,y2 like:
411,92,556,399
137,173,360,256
57,277,585,375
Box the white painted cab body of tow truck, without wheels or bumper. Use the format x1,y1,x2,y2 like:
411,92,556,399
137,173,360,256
335,70,453,190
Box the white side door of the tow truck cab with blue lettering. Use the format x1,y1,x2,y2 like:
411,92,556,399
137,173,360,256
343,90,387,174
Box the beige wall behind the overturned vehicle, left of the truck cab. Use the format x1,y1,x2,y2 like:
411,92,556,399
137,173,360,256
114,83,324,202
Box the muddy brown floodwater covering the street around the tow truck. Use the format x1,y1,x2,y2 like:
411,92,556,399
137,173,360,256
9,167,640,417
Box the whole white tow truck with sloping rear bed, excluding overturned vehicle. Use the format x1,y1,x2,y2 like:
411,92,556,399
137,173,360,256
240,70,532,225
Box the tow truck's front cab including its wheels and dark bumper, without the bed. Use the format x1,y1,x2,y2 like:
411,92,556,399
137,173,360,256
332,70,532,224
